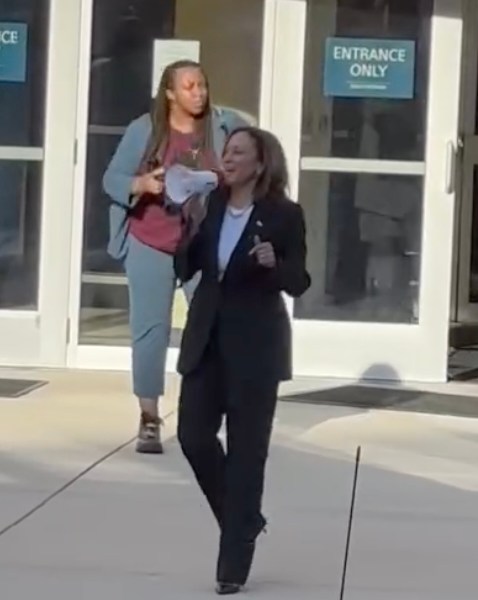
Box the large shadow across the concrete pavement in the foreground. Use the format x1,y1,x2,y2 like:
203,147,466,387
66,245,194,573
0,406,478,600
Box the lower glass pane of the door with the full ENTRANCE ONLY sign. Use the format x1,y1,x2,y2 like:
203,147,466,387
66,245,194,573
295,172,422,323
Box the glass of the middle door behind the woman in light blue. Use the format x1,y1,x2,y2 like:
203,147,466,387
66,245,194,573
80,0,264,345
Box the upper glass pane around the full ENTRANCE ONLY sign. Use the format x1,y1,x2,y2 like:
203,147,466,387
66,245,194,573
302,0,433,160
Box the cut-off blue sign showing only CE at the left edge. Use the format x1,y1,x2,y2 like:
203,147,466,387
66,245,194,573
0,23,28,83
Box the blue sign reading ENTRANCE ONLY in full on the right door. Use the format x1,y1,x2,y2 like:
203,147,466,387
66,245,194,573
324,37,415,99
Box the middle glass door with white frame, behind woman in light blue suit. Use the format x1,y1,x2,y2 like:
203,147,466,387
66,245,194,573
68,0,273,369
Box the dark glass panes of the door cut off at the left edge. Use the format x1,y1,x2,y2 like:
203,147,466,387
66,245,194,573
0,0,49,310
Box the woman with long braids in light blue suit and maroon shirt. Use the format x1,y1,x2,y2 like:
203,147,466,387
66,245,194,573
103,60,244,454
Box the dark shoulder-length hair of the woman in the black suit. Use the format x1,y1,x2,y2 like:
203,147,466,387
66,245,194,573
225,126,289,199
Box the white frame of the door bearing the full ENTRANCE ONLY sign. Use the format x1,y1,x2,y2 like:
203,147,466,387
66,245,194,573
272,0,462,382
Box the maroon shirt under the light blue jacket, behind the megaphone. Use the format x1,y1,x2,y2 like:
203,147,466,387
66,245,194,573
129,131,217,254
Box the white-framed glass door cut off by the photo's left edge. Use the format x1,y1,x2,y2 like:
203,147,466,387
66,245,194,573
0,0,79,367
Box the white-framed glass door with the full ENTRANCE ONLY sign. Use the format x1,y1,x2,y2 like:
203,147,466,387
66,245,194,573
273,0,462,381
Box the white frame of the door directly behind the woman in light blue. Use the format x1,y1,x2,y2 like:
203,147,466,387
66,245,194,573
67,0,277,371
